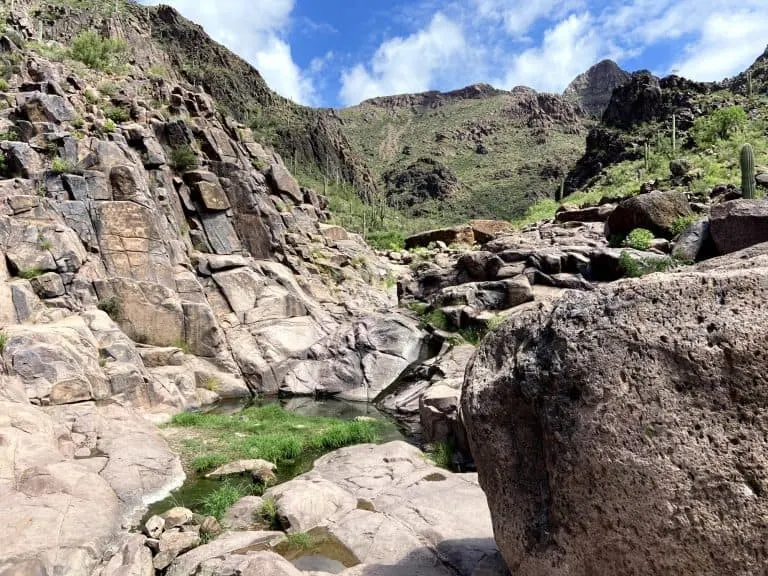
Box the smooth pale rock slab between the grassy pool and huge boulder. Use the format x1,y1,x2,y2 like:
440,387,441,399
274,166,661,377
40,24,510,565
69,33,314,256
268,442,506,576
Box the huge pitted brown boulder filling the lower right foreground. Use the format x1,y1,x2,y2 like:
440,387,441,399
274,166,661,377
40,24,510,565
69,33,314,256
461,245,768,576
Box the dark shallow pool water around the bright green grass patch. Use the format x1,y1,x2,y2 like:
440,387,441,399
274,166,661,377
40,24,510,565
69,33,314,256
142,398,412,520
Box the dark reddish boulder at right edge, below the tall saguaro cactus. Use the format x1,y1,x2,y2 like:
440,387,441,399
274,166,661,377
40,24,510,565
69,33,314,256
709,200,768,254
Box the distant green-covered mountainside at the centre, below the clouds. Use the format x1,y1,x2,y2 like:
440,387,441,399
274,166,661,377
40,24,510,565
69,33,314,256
339,84,589,223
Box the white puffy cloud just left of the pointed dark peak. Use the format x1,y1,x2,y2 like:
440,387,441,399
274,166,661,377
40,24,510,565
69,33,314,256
504,12,601,92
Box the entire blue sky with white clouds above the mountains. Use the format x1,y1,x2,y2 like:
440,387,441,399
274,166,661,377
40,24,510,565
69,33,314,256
142,0,768,107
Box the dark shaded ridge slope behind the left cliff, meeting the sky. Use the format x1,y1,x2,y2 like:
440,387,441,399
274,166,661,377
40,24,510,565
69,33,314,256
23,0,374,196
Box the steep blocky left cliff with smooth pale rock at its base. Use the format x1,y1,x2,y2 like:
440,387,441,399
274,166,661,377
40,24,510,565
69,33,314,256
0,2,436,574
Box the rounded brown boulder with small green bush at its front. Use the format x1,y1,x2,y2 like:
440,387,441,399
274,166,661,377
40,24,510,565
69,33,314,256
605,190,693,238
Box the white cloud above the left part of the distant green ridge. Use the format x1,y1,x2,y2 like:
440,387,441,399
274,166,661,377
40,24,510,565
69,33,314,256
339,12,467,104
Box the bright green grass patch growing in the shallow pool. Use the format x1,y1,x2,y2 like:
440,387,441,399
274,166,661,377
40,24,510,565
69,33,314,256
170,404,383,474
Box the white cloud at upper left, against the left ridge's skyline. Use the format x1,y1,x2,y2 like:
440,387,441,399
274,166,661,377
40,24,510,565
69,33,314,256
141,0,317,104
